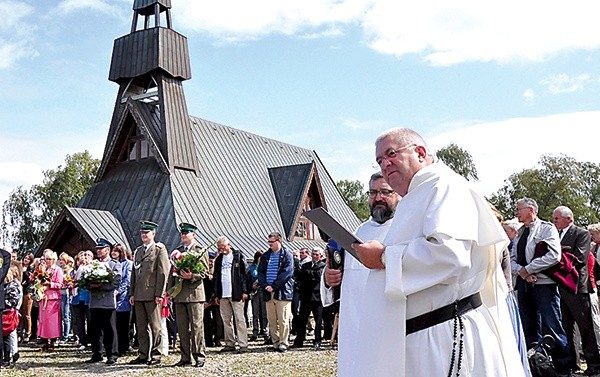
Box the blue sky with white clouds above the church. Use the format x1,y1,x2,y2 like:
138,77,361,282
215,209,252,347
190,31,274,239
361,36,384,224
0,0,600,209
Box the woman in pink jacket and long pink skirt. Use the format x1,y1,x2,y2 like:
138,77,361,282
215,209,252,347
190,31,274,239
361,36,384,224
38,249,63,352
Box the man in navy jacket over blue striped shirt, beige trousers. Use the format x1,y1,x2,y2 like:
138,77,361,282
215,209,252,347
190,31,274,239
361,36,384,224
258,232,294,352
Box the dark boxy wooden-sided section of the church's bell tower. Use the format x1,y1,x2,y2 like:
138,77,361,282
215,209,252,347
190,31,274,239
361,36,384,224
108,27,192,82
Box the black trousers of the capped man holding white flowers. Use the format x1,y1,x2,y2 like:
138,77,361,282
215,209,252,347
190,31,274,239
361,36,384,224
88,308,119,358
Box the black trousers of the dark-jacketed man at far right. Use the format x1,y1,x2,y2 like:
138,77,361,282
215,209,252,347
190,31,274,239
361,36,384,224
559,289,600,370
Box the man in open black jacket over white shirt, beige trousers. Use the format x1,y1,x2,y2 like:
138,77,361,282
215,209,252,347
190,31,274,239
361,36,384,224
214,236,248,353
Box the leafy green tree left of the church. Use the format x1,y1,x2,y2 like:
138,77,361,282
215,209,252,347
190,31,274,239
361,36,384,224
2,151,100,252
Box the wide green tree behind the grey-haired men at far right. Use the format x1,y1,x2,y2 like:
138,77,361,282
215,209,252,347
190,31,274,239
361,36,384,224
490,155,600,226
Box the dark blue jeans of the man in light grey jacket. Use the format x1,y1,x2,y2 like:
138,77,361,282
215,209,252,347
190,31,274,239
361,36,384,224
517,278,571,373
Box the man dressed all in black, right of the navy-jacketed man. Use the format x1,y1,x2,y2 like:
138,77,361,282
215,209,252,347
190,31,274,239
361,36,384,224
293,247,325,349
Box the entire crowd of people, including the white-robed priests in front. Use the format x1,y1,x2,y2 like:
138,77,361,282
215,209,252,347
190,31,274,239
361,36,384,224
0,128,600,377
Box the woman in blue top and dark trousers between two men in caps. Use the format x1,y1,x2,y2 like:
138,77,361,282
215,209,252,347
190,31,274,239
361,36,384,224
110,243,133,356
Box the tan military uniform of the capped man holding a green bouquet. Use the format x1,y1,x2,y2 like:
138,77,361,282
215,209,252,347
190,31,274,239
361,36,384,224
169,241,209,366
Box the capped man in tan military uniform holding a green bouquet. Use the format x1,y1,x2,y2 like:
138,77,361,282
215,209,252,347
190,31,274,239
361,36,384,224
169,223,209,368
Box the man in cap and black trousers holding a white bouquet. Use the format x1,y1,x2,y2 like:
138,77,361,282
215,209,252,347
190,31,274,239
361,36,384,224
86,238,121,365
